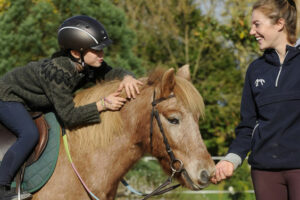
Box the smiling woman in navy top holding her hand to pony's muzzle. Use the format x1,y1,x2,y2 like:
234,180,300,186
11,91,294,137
212,0,300,200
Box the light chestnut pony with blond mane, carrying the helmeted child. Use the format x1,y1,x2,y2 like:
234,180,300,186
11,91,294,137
33,67,215,200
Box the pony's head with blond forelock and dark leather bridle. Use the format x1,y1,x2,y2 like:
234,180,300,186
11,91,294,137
137,66,215,190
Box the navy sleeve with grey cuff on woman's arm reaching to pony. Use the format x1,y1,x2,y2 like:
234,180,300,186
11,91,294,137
224,67,257,168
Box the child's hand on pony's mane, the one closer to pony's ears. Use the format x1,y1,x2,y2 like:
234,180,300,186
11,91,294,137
117,75,143,99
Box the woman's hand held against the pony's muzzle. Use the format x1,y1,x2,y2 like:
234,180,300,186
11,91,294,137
210,160,234,184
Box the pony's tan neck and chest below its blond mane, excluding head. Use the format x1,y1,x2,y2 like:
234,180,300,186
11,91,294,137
67,84,152,196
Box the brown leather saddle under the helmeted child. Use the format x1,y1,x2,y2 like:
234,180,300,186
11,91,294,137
0,112,49,166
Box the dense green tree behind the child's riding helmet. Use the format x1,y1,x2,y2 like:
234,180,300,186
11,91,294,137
0,0,144,75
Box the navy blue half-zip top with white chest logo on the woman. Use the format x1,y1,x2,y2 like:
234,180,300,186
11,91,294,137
225,46,300,169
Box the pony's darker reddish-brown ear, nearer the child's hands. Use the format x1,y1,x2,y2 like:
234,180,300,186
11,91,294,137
161,68,175,98
